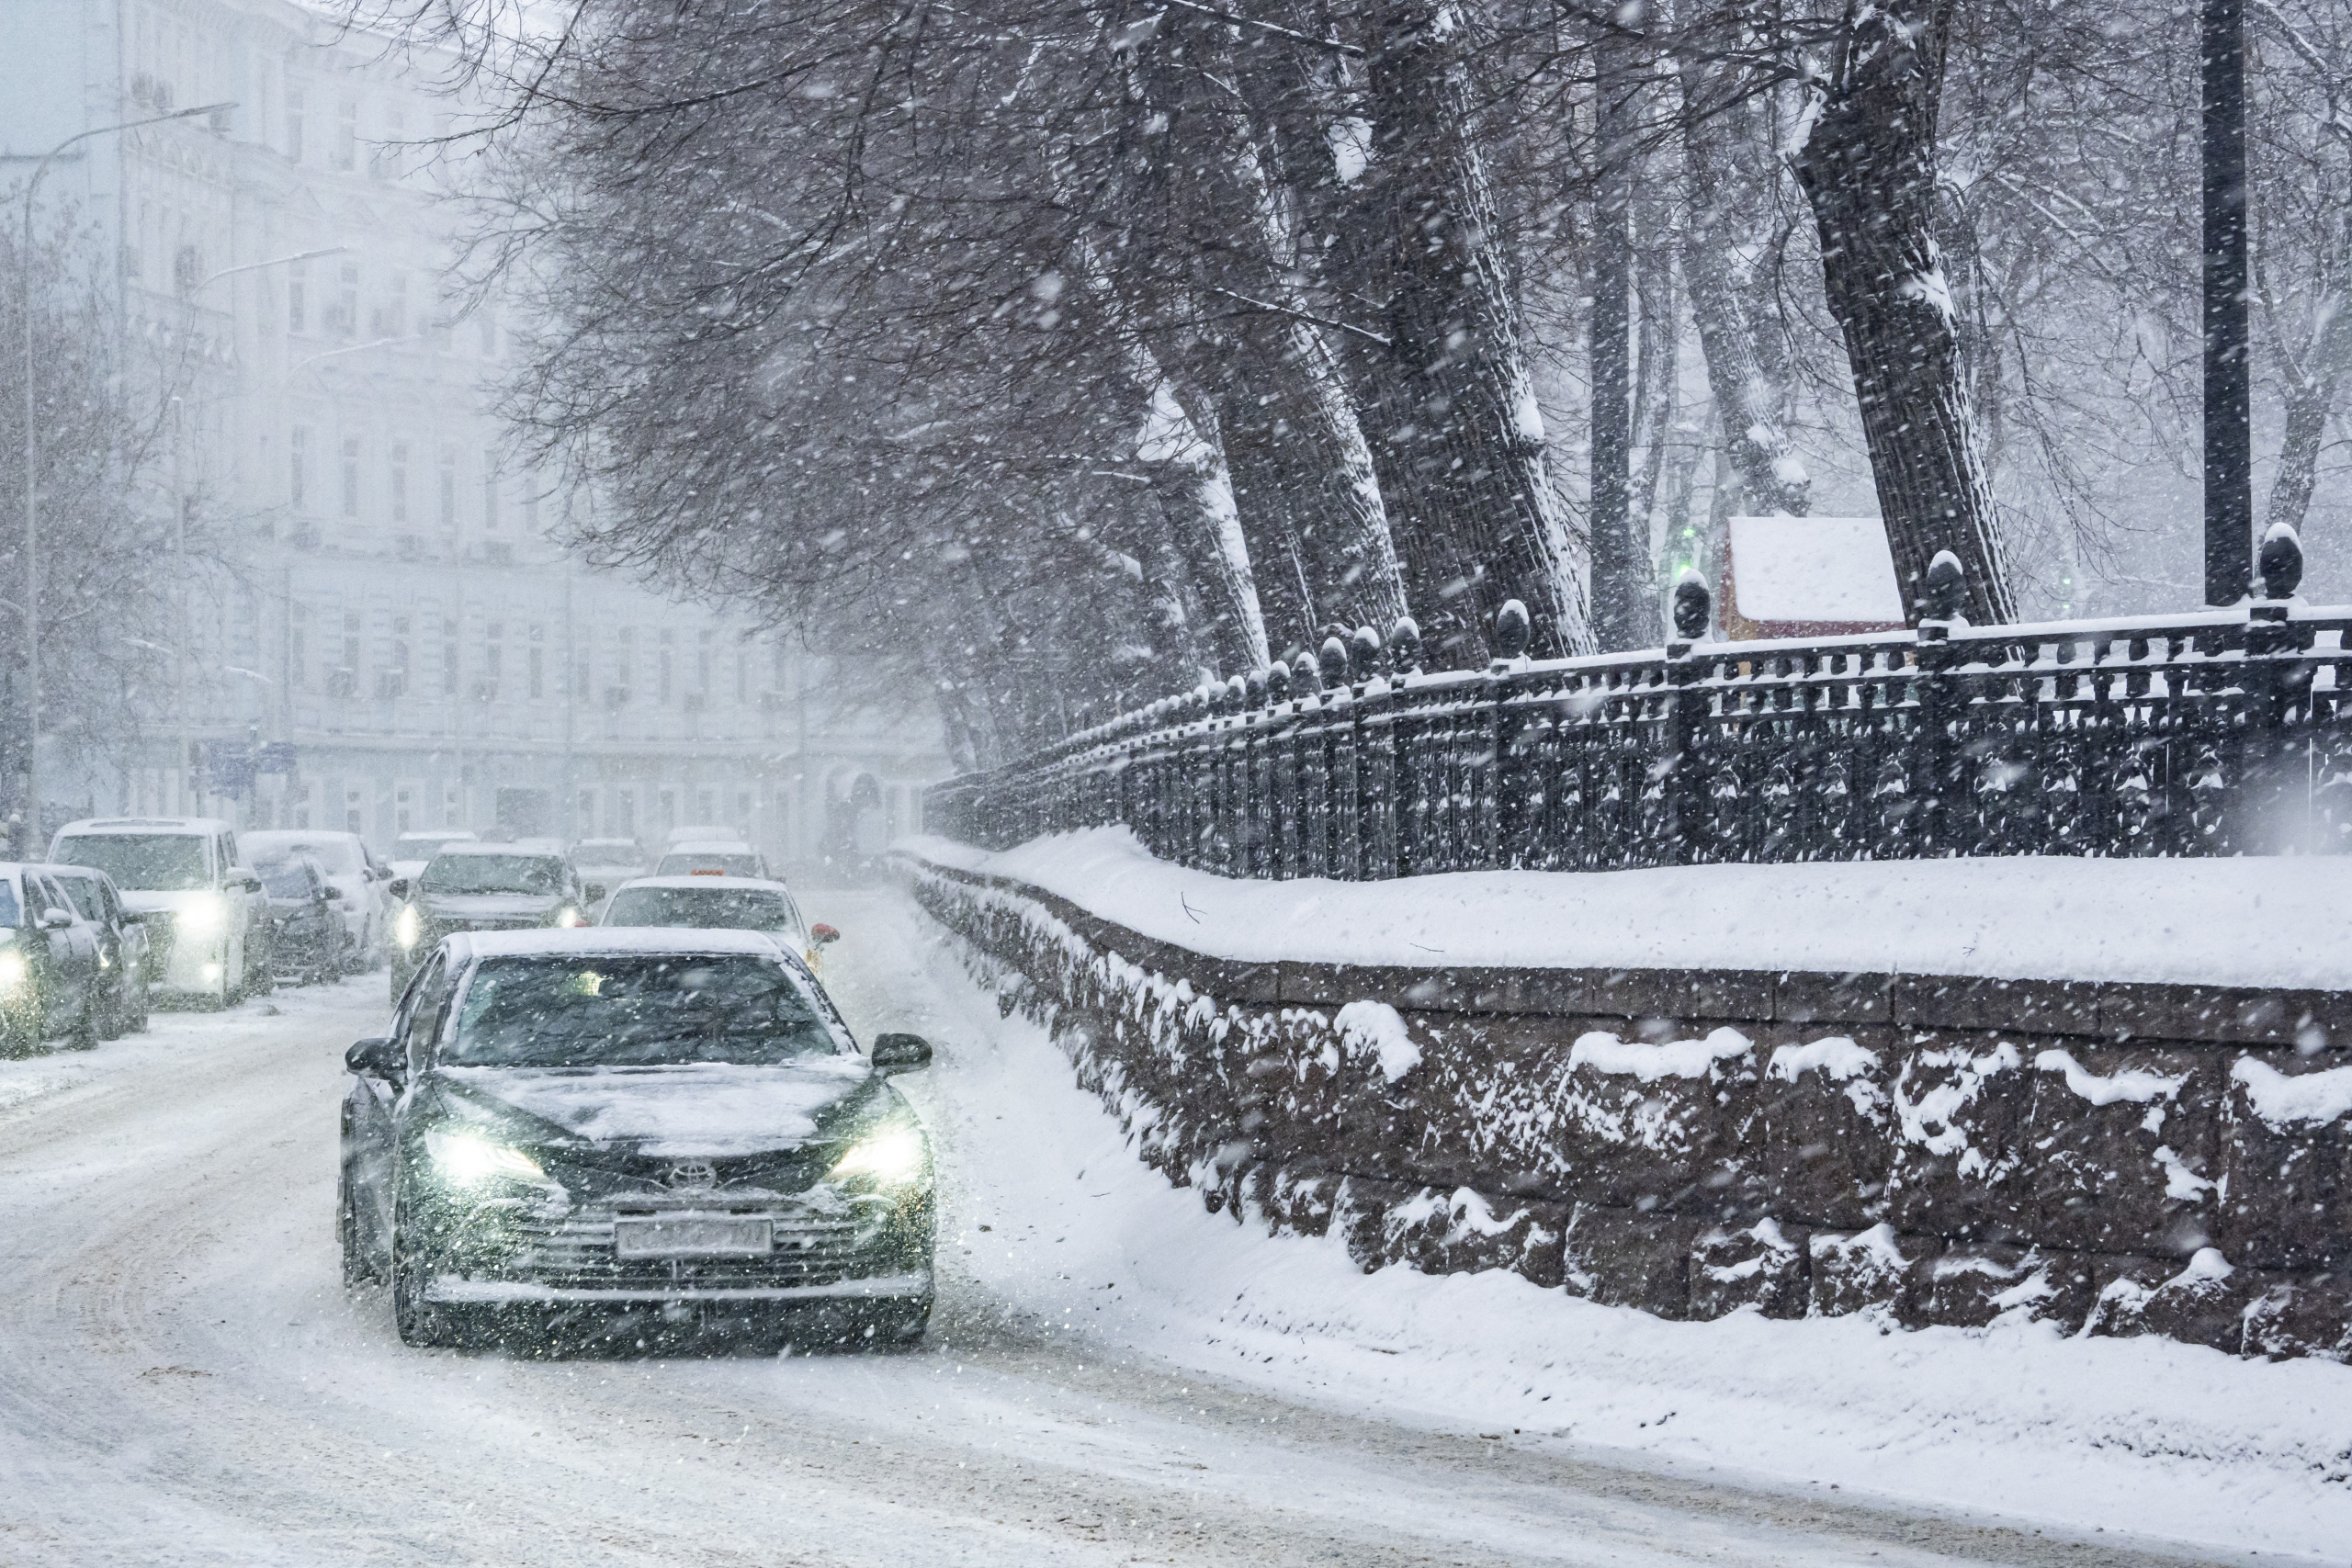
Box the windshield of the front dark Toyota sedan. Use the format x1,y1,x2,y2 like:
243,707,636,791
442,952,844,1067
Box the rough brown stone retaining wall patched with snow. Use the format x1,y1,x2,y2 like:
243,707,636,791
894,856,2352,1361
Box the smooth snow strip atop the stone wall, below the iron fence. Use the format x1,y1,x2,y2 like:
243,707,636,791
900,828,2352,989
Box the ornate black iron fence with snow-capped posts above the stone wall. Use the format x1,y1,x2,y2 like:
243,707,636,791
927,529,2352,879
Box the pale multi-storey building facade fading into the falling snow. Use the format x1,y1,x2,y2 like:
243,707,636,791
0,0,948,863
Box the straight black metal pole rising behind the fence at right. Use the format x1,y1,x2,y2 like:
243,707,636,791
2201,0,2253,604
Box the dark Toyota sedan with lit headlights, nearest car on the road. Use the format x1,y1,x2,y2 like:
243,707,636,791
336,926,936,1345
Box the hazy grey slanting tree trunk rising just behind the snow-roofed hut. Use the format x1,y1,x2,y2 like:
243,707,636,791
1679,62,1814,517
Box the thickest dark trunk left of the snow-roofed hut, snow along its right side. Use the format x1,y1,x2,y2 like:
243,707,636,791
1366,0,1592,665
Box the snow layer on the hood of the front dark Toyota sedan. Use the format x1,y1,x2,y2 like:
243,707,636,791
440,1055,873,1159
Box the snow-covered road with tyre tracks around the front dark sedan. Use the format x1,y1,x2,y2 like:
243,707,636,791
0,894,2314,1568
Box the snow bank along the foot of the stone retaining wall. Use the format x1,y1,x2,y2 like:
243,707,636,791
879,888,2352,1563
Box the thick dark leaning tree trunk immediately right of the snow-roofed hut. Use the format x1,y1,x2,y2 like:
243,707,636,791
1797,0,2016,623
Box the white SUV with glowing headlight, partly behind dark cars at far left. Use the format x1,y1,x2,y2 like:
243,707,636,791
50,816,270,1009
